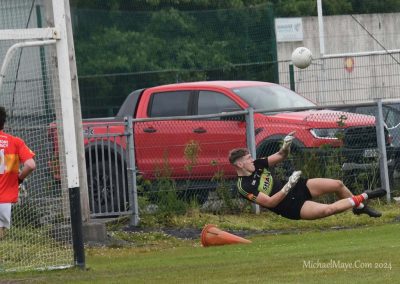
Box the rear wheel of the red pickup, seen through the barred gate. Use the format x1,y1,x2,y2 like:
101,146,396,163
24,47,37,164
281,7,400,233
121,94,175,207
87,158,129,215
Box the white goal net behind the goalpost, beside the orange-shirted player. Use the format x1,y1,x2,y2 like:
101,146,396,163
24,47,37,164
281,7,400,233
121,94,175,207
0,0,79,271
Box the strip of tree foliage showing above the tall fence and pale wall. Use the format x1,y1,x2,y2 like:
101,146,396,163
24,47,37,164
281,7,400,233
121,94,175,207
70,0,400,13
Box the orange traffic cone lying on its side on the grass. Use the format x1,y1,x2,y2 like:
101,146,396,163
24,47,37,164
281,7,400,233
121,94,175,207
201,224,251,247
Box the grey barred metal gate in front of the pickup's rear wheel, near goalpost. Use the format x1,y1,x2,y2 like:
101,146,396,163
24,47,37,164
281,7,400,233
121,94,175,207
83,119,132,217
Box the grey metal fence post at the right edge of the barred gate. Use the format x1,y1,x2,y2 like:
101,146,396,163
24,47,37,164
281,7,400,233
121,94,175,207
125,116,140,226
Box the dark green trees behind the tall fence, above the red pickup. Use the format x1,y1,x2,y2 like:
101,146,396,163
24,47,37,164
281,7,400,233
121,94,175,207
70,0,400,116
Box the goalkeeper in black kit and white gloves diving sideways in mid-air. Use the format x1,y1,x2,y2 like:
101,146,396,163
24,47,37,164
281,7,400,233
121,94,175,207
229,132,386,220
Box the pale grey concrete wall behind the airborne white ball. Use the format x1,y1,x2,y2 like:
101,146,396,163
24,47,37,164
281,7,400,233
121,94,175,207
277,13,400,104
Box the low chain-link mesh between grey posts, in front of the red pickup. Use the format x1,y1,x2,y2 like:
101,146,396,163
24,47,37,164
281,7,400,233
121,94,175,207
135,106,400,217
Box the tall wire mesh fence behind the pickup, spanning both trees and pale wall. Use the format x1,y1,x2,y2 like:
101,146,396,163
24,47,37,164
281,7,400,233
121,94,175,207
72,1,400,118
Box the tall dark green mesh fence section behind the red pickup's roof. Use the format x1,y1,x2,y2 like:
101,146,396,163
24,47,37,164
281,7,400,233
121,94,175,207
72,3,278,118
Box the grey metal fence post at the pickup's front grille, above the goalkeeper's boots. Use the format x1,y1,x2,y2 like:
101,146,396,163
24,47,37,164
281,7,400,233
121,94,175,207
376,99,390,202
